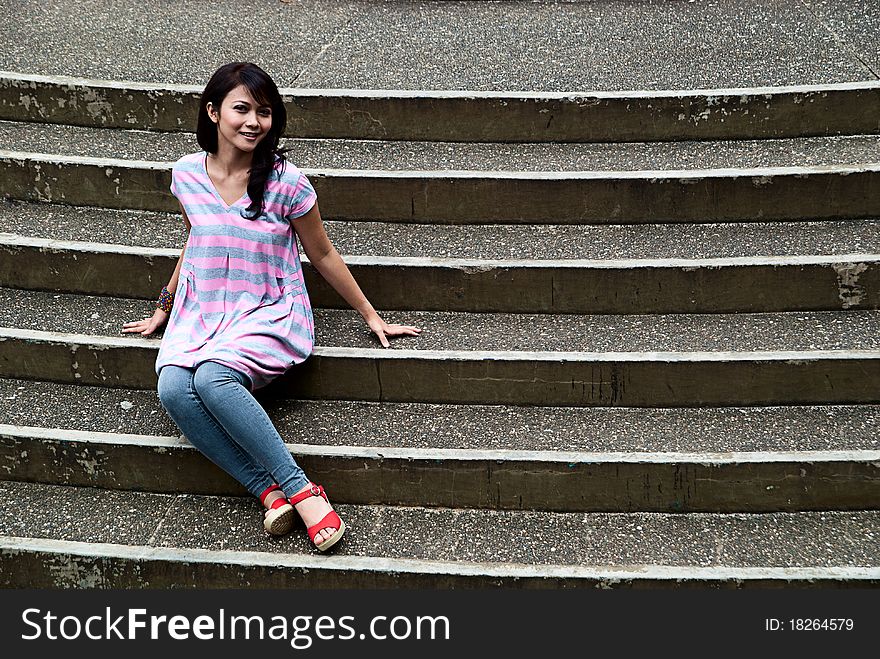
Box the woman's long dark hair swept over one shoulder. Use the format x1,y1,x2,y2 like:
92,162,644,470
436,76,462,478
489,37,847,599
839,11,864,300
196,62,287,219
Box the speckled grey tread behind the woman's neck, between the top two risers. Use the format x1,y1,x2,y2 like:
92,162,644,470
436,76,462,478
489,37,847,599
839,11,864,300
0,121,880,172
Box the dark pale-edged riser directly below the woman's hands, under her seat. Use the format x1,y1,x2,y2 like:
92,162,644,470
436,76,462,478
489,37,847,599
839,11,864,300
0,328,880,407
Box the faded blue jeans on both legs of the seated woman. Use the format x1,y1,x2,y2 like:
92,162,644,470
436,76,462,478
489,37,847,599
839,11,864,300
159,362,309,497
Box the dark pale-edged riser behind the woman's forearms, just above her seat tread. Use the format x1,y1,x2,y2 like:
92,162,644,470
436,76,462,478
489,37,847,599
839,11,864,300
6,236,880,314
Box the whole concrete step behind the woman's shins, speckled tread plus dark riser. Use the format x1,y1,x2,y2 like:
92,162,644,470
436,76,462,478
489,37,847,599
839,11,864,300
0,380,880,512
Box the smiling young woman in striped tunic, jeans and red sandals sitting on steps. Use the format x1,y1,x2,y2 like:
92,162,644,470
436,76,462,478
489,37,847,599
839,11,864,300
122,62,420,551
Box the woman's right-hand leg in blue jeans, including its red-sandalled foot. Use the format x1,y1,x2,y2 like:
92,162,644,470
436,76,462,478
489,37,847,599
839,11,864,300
193,362,336,544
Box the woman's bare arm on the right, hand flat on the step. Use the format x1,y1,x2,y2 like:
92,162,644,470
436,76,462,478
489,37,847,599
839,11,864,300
291,202,421,348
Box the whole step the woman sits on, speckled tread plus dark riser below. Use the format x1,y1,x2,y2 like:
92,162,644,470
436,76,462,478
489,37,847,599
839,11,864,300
0,289,880,407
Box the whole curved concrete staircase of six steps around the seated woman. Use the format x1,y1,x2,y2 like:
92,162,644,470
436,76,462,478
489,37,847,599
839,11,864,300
0,73,880,588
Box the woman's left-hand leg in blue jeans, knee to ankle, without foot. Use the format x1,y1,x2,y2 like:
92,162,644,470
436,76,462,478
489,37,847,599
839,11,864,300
159,366,274,496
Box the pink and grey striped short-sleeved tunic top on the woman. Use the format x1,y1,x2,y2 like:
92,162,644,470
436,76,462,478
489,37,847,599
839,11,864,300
156,152,316,389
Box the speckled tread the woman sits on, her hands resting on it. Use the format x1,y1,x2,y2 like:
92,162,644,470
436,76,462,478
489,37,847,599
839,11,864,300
0,288,880,354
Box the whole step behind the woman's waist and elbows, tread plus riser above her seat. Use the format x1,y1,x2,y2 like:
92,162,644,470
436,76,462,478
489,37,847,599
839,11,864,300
0,201,880,313
